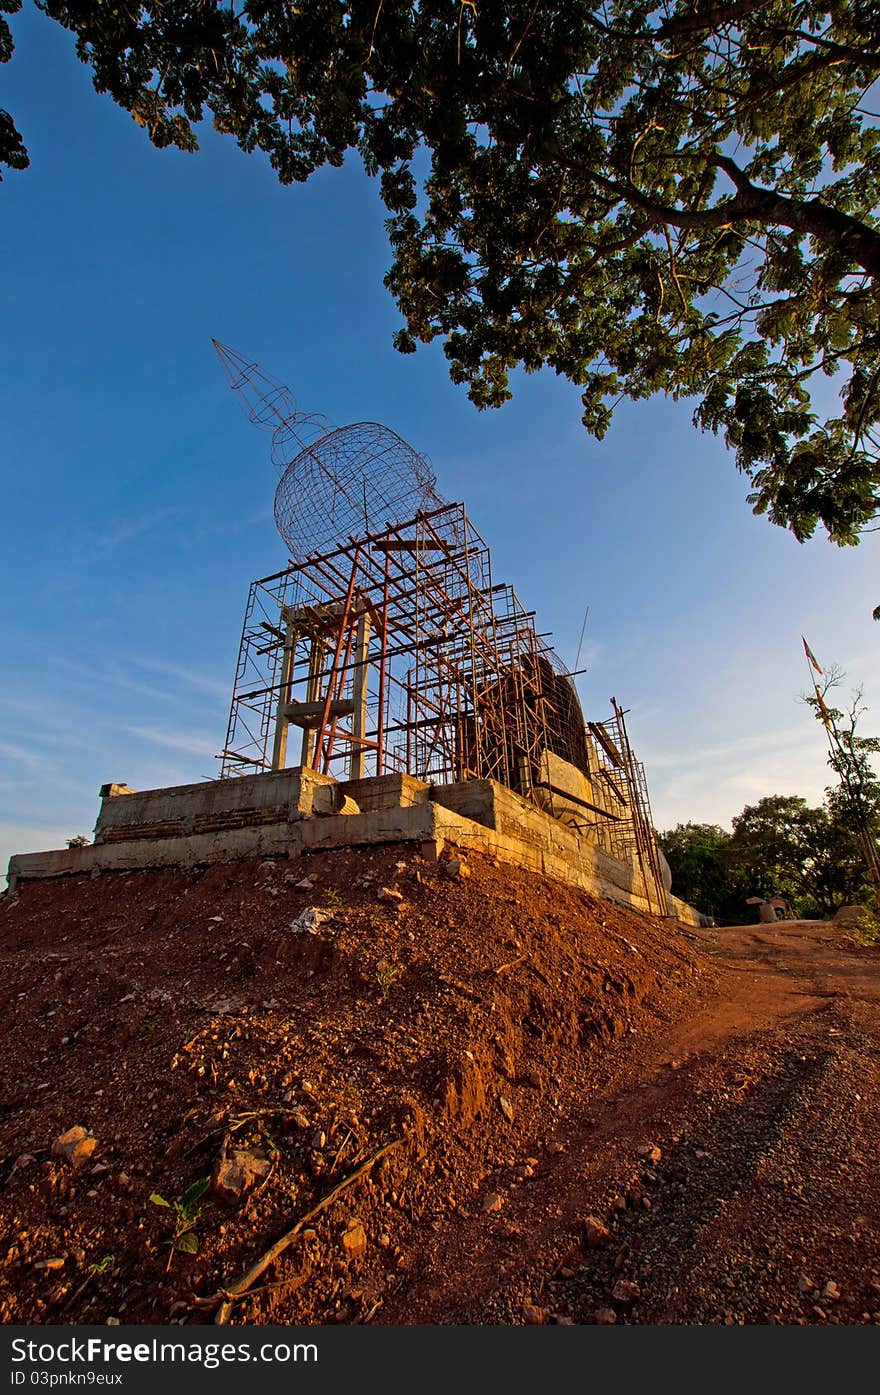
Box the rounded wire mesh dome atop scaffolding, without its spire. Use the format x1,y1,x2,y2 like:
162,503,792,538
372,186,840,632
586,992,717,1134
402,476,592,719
275,421,441,562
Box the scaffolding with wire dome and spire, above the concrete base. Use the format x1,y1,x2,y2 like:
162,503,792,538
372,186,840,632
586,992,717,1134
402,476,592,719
215,340,665,914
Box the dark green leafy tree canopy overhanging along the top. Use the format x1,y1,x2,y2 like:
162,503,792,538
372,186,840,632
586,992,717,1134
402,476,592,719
0,0,880,544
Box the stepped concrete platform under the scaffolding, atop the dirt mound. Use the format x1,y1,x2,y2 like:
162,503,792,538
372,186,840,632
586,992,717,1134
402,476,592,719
1,769,699,925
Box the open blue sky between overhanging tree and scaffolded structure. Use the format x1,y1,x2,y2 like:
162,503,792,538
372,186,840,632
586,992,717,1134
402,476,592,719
0,8,880,866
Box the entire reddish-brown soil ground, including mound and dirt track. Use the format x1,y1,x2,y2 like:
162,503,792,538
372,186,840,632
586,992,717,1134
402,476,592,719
0,848,880,1324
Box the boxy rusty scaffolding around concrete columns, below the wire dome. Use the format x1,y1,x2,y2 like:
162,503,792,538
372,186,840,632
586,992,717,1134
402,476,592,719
222,504,587,795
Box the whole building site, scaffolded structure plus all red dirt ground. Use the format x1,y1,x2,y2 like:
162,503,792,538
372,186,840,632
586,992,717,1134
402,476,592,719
0,343,880,1327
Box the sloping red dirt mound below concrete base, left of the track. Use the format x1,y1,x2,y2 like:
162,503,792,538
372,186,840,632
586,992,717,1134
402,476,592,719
0,847,715,1324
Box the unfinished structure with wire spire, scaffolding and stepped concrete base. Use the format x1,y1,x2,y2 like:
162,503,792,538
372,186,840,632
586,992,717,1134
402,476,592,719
10,342,696,919
